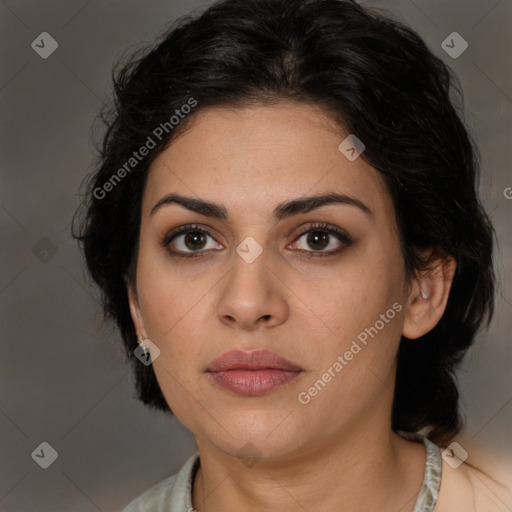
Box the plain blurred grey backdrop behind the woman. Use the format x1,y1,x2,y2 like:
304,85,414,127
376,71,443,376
0,0,512,512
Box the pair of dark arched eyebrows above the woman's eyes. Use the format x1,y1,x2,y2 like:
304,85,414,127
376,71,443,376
149,192,373,221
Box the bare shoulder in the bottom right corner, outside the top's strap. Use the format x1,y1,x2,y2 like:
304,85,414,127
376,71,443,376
435,454,512,512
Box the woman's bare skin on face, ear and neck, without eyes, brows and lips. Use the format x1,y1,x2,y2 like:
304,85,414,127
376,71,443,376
128,102,455,512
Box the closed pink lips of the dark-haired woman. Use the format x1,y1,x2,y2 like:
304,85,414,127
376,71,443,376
206,350,302,396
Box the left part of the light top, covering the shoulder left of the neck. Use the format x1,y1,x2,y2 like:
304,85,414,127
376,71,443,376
122,454,199,512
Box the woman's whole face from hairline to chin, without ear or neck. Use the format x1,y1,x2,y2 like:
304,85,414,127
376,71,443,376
130,102,416,457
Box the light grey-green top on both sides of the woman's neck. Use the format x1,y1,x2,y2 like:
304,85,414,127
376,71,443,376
122,432,443,512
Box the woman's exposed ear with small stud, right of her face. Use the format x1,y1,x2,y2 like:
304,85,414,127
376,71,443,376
402,249,457,339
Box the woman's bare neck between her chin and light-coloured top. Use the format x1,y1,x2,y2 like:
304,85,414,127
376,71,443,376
192,426,425,512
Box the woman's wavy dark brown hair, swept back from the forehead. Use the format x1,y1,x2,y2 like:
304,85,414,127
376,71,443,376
74,0,495,445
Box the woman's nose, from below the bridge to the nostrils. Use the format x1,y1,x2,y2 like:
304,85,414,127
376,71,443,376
217,251,289,331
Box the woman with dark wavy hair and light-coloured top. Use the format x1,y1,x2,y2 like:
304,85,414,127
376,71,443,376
77,0,508,512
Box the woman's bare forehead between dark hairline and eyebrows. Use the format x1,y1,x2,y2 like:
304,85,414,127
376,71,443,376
143,102,392,221
